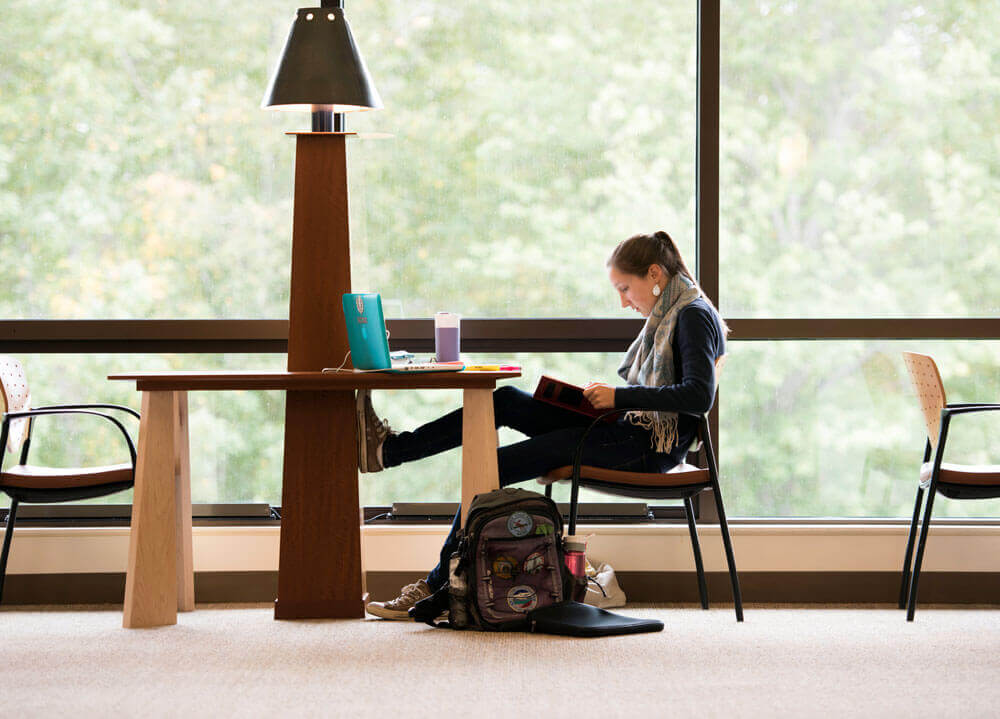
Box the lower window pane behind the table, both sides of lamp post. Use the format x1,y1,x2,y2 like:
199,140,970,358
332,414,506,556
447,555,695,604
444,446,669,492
0,353,660,506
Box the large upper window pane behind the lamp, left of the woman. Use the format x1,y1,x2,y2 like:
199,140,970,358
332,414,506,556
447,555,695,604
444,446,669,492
0,0,696,319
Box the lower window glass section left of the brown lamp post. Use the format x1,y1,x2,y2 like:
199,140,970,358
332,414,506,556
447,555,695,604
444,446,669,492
3,354,285,506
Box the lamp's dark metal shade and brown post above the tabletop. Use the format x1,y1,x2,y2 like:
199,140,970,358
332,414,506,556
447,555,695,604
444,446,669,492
262,0,382,371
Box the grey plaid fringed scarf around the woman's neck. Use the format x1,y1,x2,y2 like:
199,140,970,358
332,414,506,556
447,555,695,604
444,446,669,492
618,272,701,452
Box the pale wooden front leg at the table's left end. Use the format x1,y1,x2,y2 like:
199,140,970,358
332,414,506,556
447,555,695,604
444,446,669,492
122,392,177,628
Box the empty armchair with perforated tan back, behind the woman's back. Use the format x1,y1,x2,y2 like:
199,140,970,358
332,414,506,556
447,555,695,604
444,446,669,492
899,352,1000,622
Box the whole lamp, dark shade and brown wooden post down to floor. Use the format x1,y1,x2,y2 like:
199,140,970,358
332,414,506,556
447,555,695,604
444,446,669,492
263,0,382,619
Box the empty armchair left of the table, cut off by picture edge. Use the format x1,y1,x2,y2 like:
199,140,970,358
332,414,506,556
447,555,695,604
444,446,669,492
0,355,139,601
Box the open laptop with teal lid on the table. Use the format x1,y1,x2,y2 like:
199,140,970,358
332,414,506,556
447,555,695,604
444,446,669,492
343,292,465,372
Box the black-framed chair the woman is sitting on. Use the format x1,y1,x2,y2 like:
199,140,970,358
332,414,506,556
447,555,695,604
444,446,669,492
539,409,743,622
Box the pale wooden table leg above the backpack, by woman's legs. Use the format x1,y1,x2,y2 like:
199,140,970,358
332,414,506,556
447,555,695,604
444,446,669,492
462,389,500,526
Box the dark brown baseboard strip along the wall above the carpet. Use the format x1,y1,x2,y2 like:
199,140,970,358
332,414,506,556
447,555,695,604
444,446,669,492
3,571,1000,607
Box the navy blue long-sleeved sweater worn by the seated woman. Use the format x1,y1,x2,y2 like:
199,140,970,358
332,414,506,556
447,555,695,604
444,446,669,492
615,297,726,469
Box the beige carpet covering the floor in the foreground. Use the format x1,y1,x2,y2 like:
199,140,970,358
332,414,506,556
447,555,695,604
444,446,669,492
0,605,1000,719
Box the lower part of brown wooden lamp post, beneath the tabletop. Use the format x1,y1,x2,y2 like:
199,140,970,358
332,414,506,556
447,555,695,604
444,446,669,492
274,390,364,619
